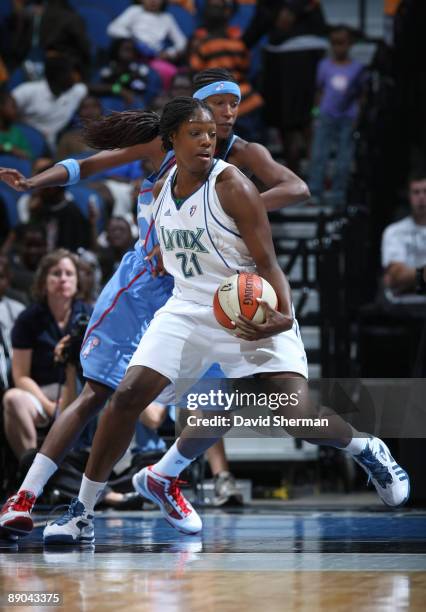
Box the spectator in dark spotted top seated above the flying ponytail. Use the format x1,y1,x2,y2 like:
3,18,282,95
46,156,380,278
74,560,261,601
90,38,162,106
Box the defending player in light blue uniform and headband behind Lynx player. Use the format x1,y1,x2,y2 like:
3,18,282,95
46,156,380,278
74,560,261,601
0,70,309,535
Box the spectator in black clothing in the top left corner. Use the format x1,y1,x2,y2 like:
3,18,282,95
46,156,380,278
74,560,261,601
2,0,90,79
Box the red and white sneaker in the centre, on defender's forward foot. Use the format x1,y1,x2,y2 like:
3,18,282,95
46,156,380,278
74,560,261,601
132,465,203,535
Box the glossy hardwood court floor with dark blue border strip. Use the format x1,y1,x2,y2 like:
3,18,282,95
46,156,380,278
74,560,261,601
0,507,426,612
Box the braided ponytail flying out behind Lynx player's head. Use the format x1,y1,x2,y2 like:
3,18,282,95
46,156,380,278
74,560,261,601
83,110,160,150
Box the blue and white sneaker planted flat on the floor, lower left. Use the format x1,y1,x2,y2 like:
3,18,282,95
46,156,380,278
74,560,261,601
43,497,95,544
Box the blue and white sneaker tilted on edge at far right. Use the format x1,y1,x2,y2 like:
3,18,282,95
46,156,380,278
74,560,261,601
352,438,410,508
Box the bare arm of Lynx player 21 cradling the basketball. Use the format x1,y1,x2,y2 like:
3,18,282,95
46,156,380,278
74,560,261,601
216,168,293,340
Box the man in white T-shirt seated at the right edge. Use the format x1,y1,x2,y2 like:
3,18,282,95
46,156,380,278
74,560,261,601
382,172,426,300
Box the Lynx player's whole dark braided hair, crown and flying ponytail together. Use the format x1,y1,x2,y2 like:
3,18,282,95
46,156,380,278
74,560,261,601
83,96,212,151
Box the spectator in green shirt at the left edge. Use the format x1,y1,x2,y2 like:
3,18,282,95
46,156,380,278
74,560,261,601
0,91,32,159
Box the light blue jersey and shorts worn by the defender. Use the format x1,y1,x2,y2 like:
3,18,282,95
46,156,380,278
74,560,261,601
80,142,236,389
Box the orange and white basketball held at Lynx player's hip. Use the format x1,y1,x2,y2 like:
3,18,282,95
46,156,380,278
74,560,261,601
213,272,278,332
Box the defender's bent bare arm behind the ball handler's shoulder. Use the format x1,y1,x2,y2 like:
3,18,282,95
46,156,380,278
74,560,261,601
230,140,310,211
